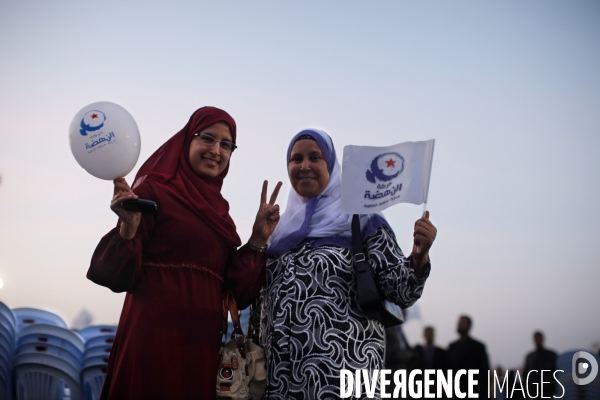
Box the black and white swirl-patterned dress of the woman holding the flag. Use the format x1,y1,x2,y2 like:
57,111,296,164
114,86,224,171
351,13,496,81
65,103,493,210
253,226,429,400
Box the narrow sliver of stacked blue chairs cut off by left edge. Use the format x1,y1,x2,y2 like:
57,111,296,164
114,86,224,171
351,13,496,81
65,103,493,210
0,301,17,400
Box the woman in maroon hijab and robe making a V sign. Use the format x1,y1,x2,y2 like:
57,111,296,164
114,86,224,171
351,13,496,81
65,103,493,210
87,107,281,399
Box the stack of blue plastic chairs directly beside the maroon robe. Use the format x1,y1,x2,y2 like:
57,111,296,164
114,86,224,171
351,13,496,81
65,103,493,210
78,325,117,400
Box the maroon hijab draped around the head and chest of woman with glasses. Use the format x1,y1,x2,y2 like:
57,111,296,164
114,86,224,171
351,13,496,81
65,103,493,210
133,107,241,250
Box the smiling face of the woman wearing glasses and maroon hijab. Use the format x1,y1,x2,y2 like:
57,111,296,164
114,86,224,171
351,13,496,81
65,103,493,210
189,122,232,178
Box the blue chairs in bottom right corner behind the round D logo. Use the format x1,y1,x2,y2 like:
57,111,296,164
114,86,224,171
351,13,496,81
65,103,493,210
555,350,600,400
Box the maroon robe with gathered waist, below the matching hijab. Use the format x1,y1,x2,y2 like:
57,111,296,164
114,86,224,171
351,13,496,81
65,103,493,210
88,183,266,400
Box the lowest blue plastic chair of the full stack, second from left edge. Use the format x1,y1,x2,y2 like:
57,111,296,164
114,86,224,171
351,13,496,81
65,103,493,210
13,353,83,400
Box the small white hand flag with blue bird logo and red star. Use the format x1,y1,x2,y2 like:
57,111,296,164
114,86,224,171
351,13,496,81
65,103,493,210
342,139,435,214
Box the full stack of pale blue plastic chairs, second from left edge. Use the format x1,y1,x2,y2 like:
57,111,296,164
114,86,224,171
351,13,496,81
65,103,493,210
13,308,84,400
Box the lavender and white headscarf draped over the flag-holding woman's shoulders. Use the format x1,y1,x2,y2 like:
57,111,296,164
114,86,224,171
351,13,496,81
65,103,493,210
267,129,389,257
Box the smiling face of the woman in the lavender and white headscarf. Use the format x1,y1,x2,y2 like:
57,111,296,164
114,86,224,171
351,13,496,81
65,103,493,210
288,139,329,197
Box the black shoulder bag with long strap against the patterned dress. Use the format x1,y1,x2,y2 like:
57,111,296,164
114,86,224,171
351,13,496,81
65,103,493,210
352,214,404,328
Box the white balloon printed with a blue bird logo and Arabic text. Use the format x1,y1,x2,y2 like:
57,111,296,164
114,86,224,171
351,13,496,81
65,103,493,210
69,101,141,180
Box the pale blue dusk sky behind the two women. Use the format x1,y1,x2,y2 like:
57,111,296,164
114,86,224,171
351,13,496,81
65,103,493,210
0,0,600,367
